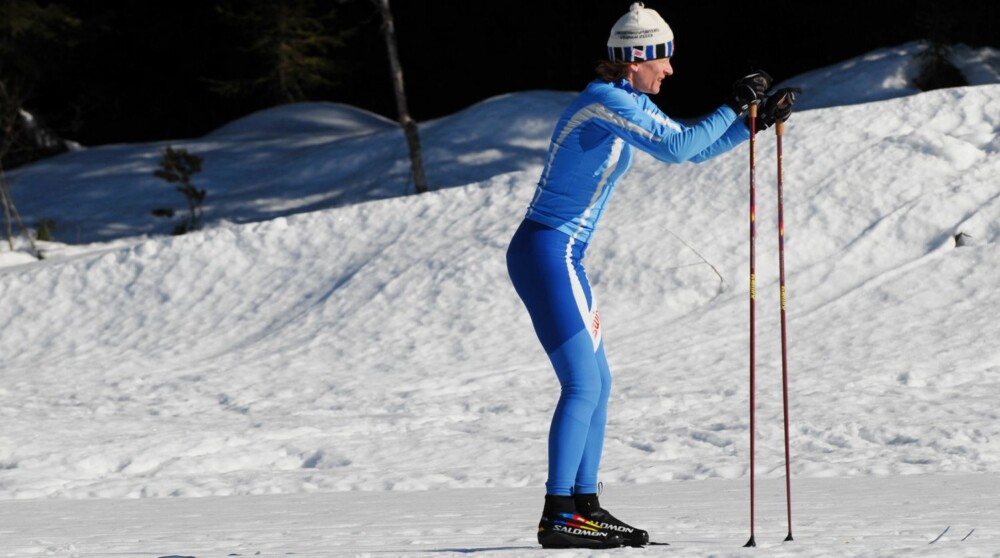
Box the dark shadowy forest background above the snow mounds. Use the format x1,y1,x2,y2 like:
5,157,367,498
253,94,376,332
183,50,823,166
0,0,1000,152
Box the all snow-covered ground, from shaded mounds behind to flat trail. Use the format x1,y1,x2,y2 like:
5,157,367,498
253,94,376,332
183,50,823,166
0,44,1000,557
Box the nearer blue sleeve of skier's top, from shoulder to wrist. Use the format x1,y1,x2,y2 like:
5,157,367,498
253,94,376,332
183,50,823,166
588,92,749,163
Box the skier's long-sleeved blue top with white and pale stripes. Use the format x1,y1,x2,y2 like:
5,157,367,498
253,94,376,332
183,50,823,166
525,79,750,243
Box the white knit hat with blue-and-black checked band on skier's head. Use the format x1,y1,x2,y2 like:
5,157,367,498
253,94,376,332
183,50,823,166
608,2,674,62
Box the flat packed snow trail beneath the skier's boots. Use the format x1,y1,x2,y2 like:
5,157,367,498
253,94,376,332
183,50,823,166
0,474,1000,558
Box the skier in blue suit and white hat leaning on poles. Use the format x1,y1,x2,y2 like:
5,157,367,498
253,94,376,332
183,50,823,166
507,2,794,548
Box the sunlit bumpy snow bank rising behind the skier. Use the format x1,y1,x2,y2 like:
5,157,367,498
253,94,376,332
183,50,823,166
0,85,1000,504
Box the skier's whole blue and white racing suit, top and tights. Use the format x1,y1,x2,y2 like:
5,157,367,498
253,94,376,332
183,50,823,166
507,80,750,496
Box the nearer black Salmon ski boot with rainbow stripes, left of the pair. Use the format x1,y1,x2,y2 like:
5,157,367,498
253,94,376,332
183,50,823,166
538,495,622,548
